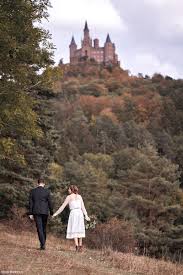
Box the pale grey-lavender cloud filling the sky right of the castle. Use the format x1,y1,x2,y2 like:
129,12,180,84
112,0,183,78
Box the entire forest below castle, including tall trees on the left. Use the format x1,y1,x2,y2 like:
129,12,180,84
0,0,183,264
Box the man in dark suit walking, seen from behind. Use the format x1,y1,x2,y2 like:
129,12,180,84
29,179,53,250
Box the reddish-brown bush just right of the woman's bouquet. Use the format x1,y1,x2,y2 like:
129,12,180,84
86,218,135,252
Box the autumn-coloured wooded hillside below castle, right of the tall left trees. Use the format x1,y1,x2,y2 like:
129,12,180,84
50,63,183,258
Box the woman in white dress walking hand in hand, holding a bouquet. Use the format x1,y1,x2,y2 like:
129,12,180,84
52,185,90,251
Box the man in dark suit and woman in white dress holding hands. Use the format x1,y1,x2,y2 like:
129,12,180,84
29,179,90,251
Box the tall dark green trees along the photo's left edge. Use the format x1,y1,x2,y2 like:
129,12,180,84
0,0,53,217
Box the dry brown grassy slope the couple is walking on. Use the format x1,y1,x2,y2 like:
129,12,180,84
0,224,183,275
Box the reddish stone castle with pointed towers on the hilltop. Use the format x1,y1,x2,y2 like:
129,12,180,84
69,21,120,65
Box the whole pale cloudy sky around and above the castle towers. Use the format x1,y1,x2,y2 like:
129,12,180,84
43,0,183,79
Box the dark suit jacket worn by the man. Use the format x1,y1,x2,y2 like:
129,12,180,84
29,186,53,215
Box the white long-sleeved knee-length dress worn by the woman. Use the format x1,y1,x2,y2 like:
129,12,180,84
54,194,88,239
